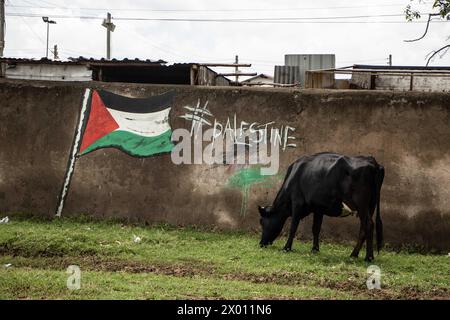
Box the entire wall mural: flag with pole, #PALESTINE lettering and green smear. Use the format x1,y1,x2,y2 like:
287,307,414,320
56,89,297,216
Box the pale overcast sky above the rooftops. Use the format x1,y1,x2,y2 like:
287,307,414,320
4,0,450,75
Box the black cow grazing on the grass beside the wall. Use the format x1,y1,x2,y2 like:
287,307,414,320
259,152,384,261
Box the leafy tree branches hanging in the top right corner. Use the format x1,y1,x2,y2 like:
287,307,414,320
405,0,450,66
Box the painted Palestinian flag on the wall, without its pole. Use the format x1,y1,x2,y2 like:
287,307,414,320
78,90,174,157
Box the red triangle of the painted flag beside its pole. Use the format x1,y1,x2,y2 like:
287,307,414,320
80,90,119,153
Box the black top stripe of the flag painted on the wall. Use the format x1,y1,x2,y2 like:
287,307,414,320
97,90,175,113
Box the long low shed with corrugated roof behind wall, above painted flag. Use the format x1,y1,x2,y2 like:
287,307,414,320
0,57,230,86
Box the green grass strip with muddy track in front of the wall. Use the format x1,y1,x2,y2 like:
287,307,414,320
0,216,450,299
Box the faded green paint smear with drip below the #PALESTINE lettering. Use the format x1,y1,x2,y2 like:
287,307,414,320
227,166,282,216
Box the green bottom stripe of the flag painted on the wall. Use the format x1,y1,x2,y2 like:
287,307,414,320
81,130,174,157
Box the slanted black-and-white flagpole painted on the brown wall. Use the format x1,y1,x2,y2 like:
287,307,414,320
56,89,91,217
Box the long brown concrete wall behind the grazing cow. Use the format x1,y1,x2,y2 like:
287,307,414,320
0,80,450,249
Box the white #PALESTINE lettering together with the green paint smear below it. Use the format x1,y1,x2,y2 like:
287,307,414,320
180,99,297,216
